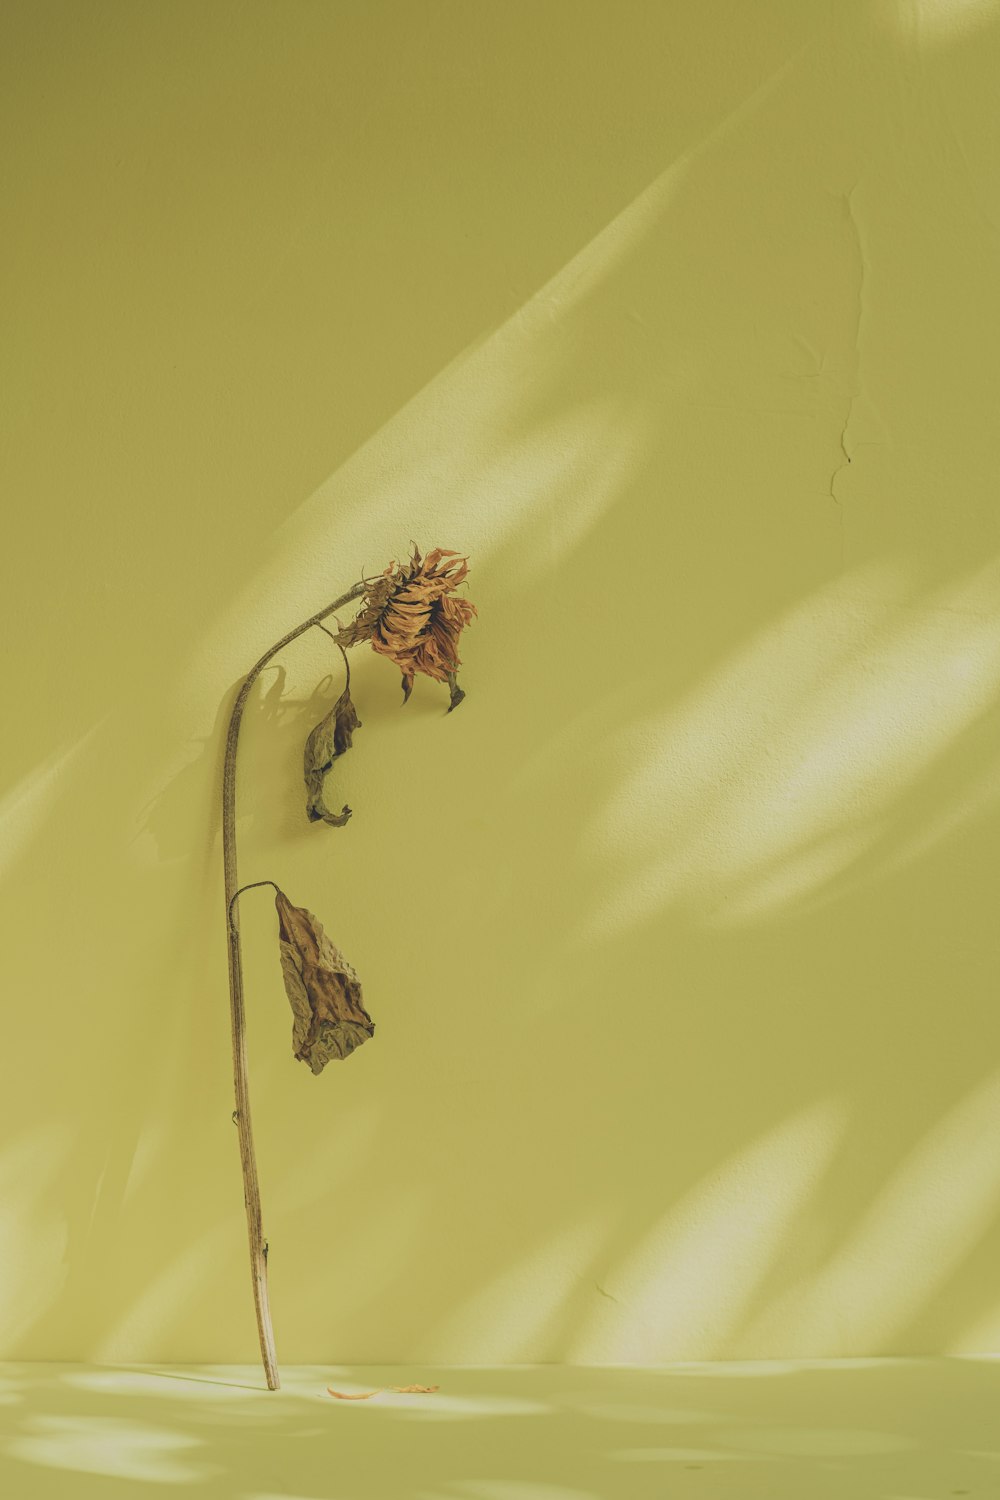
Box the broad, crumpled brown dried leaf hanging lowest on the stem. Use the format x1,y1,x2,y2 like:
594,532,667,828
274,891,375,1073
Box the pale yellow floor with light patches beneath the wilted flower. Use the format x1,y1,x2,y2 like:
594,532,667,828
0,1358,1000,1500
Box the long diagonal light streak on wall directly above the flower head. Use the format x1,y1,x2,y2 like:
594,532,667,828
184,42,811,708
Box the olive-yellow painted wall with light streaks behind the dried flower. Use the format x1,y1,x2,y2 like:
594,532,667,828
0,0,1000,1364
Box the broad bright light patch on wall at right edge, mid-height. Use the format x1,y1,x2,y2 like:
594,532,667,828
585,564,1000,933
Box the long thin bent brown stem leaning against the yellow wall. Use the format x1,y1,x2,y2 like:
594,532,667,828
222,582,364,1391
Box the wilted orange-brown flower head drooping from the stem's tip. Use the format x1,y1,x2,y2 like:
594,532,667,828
337,546,477,708
